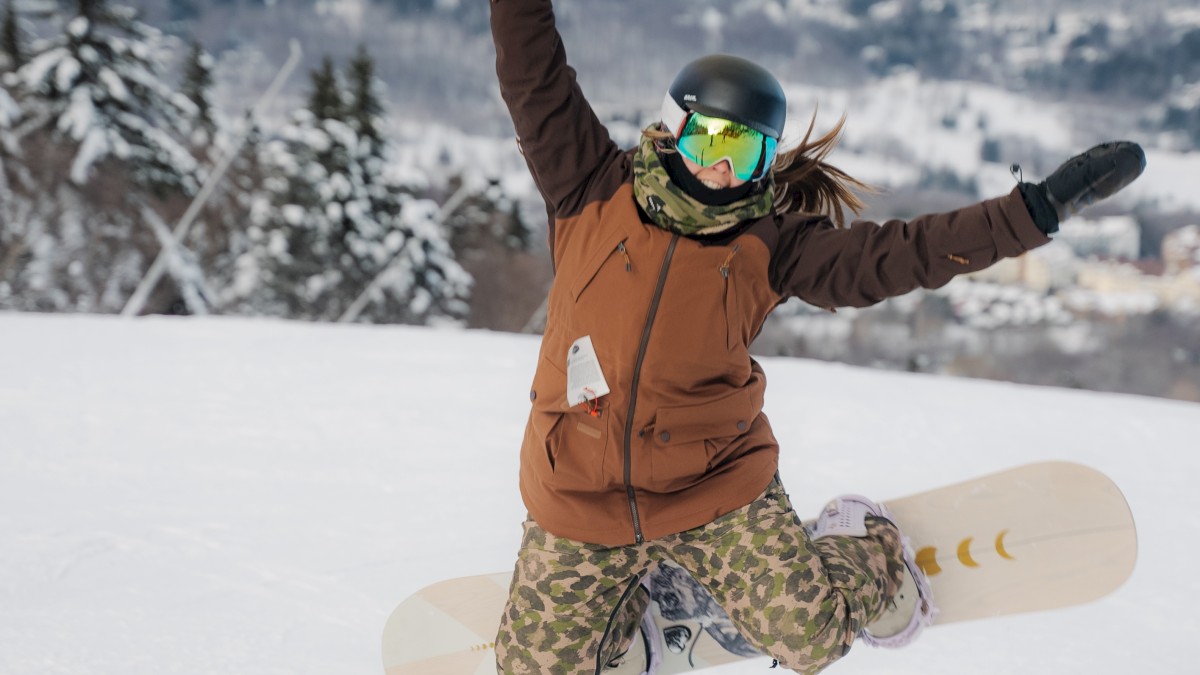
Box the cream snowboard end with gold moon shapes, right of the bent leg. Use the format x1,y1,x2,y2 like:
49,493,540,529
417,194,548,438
886,462,1138,625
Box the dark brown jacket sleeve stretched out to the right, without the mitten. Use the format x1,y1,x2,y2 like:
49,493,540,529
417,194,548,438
770,190,1050,309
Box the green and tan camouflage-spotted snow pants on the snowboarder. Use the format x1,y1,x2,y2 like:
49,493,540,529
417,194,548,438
496,480,904,675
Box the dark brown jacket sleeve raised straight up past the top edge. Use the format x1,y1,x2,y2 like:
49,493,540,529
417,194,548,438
491,0,619,216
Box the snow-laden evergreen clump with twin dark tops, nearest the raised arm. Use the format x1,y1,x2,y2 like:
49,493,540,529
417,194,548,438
239,52,470,323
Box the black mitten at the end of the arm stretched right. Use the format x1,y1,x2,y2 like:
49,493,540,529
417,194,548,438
1020,141,1146,234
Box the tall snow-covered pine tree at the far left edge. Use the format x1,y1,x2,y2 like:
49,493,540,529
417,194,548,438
0,0,198,312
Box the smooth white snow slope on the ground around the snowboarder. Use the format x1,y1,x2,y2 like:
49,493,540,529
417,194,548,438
0,313,1200,675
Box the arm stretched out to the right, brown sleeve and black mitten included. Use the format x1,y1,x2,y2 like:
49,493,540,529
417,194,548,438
770,141,1146,307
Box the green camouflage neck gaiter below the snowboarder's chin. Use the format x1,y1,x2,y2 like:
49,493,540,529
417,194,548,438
634,128,773,235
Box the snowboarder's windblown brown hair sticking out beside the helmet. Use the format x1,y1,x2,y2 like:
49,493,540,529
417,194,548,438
642,110,877,227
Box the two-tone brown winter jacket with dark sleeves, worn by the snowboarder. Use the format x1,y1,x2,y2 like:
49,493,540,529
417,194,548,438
492,0,1049,545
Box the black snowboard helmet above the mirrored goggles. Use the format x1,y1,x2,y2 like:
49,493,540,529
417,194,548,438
662,54,787,141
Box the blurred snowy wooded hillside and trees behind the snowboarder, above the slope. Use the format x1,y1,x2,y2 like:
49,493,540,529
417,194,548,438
0,0,1200,399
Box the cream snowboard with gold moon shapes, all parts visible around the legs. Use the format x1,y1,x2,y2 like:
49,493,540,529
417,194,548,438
383,462,1138,675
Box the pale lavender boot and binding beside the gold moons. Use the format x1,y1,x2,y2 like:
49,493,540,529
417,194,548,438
808,495,937,647
